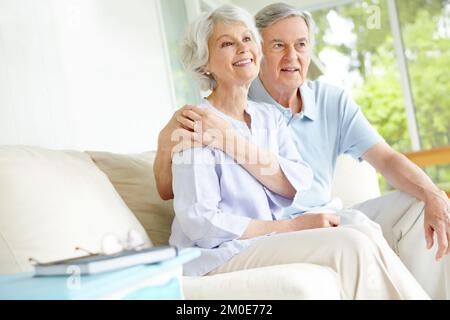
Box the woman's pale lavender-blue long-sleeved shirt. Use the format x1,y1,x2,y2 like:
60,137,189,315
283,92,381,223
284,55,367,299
169,100,313,276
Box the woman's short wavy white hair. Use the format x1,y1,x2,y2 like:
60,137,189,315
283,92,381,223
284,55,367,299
181,4,261,90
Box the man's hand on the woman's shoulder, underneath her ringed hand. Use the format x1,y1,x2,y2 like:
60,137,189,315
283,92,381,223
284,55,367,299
158,105,201,155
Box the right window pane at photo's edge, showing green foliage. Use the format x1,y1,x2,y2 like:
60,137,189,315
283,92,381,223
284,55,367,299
397,0,450,190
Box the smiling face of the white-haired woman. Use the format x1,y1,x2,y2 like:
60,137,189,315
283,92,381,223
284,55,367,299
206,22,260,86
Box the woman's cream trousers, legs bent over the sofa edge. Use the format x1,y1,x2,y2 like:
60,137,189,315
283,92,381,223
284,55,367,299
209,210,429,299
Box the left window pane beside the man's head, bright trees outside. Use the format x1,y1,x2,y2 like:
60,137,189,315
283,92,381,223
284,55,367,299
312,0,411,155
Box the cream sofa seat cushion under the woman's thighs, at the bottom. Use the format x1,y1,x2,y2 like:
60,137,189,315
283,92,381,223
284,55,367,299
182,263,341,300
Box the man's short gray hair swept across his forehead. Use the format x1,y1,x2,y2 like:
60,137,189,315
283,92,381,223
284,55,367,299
255,2,315,50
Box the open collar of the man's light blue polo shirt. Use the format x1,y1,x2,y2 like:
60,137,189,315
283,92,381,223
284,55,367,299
249,77,317,120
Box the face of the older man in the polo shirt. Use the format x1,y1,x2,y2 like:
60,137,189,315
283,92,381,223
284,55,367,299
260,17,311,92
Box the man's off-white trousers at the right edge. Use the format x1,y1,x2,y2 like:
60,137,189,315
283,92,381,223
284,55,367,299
353,191,450,299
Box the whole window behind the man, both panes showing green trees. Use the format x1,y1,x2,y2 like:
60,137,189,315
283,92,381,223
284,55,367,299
310,0,450,190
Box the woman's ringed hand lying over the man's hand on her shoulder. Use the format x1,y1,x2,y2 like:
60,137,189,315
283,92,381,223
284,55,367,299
177,107,235,151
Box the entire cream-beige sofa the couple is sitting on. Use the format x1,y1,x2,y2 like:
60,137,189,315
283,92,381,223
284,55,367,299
0,146,379,299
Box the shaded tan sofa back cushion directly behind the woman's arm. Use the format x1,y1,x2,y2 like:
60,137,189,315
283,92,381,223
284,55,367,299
87,151,175,245
